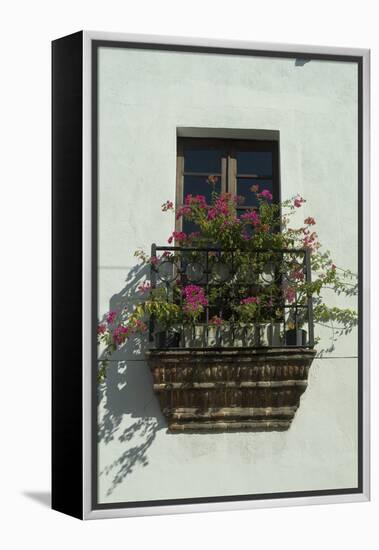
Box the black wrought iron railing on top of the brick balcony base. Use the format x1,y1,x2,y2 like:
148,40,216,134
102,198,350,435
149,244,314,348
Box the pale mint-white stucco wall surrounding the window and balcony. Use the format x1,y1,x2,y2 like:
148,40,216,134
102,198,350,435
98,48,358,502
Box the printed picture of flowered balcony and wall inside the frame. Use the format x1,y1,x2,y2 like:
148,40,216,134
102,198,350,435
93,43,361,508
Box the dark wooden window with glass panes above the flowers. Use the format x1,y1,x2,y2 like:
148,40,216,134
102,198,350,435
176,138,280,232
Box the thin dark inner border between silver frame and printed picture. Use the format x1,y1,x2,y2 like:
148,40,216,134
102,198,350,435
91,40,364,512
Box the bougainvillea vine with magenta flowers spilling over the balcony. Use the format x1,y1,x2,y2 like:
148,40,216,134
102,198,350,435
97,183,357,382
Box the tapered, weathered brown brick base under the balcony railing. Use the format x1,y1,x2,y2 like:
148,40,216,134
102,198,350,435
146,347,316,433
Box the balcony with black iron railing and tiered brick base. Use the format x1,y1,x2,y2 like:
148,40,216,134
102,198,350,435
147,245,315,432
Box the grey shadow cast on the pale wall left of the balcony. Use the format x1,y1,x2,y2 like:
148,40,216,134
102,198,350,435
98,265,166,496
